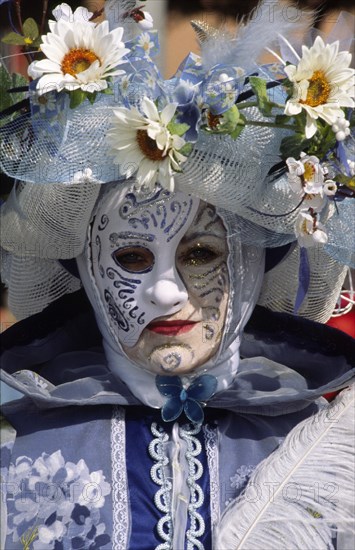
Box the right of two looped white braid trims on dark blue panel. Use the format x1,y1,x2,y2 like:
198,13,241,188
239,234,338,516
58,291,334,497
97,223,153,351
180,425,206,550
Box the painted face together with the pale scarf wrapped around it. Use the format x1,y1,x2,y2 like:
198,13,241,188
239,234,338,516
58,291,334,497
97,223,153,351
77,182,264,408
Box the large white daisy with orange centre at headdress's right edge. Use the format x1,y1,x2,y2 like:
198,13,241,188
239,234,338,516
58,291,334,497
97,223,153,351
284,36,354,138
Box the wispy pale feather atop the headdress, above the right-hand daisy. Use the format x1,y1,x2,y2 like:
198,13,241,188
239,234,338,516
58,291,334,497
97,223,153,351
201,1,311,72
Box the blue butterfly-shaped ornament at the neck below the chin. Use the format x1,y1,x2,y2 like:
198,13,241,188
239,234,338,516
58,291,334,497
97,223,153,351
155,374,217,424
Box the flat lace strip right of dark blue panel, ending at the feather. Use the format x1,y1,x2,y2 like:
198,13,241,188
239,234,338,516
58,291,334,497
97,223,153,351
202,424,220,534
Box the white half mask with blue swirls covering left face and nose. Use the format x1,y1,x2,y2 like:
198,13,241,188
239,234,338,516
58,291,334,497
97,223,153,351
91,187,199,347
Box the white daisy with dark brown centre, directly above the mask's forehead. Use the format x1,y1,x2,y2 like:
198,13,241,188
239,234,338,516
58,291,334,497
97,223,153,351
107,97,186,191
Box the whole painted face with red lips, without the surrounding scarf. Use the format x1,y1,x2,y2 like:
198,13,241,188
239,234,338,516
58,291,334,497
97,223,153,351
86,184,228,373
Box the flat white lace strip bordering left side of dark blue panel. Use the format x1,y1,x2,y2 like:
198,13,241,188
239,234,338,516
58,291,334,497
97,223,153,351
111,407,129,550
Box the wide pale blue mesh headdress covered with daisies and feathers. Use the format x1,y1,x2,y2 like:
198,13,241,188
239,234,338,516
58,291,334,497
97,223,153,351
0,0,355,321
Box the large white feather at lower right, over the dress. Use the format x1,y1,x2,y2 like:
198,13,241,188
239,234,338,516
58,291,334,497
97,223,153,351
214,386,355,550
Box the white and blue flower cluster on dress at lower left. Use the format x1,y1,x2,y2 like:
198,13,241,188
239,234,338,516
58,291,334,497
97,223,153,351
7,451,111,550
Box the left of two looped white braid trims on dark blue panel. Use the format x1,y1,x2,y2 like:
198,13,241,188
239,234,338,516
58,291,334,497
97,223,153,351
148,422,173,550
